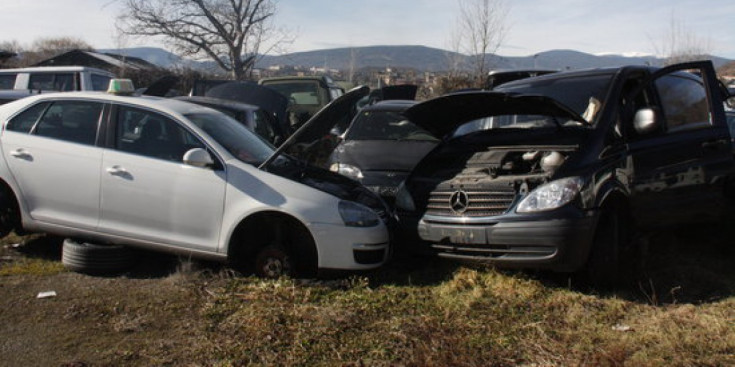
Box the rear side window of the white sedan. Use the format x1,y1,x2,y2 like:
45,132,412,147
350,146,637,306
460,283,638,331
33,101,102,145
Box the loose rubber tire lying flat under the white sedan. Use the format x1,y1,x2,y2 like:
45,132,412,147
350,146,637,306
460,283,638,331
61,238,136,274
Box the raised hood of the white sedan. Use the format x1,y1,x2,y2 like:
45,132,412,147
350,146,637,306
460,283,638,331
260,86,370,170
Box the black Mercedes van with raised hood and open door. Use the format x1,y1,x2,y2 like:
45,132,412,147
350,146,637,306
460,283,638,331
396,62,735,284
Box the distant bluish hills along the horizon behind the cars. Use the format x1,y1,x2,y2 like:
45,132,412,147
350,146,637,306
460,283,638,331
100,46,732,71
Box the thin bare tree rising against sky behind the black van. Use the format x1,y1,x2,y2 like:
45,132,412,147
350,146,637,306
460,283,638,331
454,0,508,82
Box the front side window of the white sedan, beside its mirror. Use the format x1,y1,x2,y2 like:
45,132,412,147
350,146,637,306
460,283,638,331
115,106,204,163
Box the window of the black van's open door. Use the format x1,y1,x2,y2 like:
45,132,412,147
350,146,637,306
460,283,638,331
656,72,711,131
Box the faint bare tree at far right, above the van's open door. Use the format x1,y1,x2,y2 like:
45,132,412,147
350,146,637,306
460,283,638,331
654,13,711,65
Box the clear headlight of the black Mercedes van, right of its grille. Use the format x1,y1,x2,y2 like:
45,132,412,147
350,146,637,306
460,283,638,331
516,177,583,213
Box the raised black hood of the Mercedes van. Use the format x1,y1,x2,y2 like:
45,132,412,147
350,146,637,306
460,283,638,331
403,91,589,139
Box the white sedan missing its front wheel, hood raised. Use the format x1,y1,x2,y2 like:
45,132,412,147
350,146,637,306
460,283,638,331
0,83,389,277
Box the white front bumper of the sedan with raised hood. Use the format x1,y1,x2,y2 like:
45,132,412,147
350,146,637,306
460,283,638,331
310,223,390,270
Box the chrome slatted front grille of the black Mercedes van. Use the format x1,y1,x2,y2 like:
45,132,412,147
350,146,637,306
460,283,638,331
426,187,516,217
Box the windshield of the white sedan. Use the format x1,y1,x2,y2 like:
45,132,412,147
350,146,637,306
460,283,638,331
184,112,274,166
